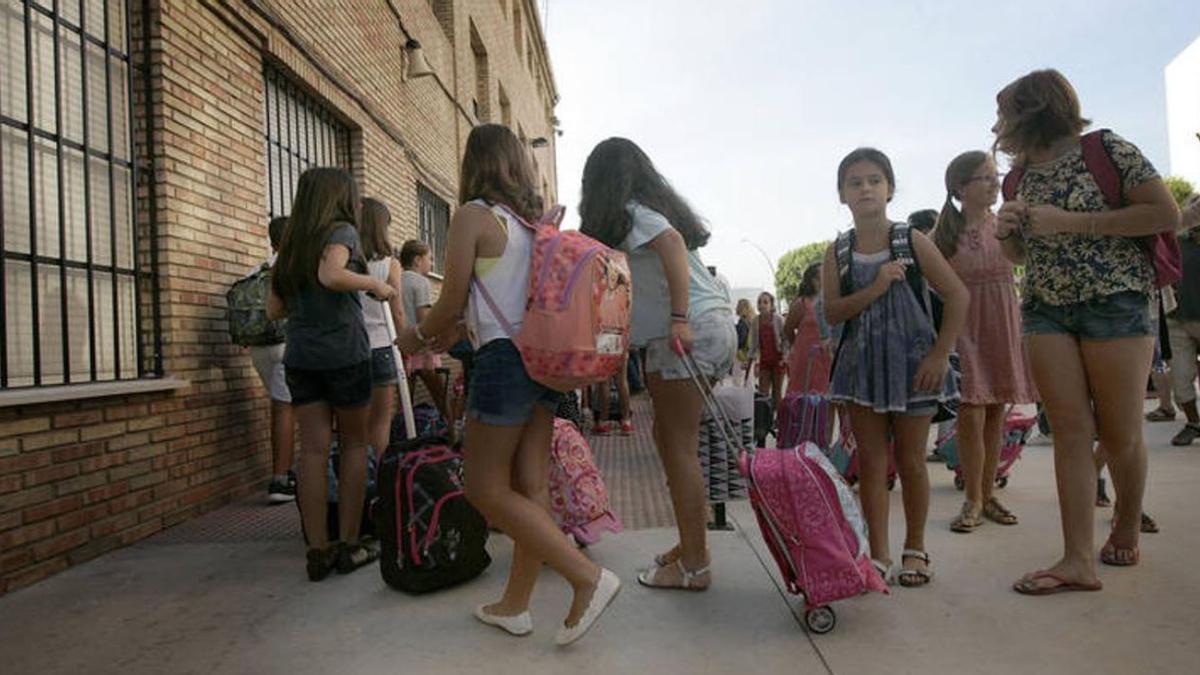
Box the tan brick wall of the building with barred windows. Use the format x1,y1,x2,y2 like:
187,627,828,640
0,0,556,593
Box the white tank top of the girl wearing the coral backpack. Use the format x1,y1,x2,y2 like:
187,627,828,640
467,199,534,350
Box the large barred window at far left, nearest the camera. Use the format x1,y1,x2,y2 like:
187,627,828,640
0,0,148,389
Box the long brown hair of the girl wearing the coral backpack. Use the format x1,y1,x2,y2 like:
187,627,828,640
458,124,542,222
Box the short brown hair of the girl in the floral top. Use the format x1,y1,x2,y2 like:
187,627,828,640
992,68,1092,165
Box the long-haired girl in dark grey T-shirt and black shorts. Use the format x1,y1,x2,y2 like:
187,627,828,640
266,168,396,581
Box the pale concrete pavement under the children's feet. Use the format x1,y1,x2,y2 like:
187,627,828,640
0,396,1200,675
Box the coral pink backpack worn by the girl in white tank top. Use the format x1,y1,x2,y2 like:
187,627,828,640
472,204,632,392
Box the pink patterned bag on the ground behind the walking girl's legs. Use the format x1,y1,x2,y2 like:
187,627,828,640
550,418,623,544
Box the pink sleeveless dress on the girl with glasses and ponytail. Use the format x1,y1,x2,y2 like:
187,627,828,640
949,216,1038,406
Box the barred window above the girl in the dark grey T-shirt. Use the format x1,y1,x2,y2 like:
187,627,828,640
264,66,350,219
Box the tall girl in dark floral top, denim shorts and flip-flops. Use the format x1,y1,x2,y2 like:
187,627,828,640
992,70,1180,595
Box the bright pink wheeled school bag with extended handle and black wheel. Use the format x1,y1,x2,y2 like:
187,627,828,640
676,346,888,634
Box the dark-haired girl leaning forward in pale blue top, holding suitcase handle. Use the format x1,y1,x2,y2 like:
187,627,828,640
580,138,737,591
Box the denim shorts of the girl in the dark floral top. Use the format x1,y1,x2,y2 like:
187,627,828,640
1021,291,1154,340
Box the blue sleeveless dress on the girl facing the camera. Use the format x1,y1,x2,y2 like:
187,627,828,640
829,251,959,413
